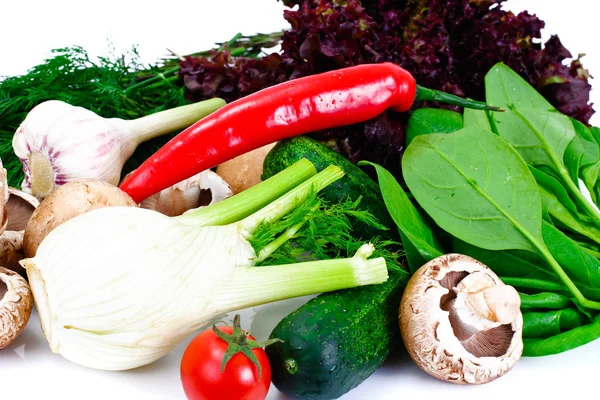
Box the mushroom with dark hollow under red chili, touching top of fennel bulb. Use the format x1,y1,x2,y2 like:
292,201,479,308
140,170,233,217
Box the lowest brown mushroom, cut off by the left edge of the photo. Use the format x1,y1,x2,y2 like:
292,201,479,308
0,267,33,350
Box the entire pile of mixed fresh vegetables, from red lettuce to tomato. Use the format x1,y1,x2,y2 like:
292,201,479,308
0,0,600,400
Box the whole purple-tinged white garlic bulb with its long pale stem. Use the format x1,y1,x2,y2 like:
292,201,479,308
12,99,225,199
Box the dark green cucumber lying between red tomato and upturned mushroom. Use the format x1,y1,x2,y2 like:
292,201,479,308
266,271,409,400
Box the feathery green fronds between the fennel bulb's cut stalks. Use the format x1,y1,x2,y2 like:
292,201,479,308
250,194,405,271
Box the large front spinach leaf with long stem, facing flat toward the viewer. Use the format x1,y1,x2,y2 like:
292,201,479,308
402,127,600,309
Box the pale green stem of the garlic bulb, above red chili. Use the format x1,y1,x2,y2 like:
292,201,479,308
126,98,226,146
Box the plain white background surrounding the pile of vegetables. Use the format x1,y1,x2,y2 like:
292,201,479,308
0,0,600,400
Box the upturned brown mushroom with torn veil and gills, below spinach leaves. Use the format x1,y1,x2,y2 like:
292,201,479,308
400,254,523,384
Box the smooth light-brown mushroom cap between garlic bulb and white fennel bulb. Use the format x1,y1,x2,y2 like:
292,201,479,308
23,179,137,258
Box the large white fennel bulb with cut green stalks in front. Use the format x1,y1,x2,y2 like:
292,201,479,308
22,160,388,370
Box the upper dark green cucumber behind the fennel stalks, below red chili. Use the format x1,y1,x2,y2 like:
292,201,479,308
262,136,398,240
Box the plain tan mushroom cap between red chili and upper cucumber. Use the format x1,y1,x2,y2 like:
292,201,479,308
217,143,276,193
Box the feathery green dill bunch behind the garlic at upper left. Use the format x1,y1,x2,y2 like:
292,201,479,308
0,32,281,187
